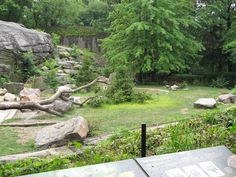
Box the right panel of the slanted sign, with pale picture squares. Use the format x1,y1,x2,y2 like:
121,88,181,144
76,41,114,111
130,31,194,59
136,146,236,177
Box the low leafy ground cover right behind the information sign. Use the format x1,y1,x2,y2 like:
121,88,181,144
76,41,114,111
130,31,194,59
0,107,236,177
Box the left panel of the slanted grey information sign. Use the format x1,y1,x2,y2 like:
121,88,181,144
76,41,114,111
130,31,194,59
22,160,147,177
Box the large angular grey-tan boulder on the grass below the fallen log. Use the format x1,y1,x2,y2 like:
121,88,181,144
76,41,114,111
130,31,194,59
35,116,89,148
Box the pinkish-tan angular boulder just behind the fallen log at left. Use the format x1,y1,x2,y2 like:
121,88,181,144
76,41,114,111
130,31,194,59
20,88,40,101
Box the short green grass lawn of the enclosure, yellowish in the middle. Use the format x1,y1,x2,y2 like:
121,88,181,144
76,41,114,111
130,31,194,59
0,86,229,155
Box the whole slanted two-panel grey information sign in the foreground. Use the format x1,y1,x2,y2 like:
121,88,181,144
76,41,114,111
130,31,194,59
21,146,236,177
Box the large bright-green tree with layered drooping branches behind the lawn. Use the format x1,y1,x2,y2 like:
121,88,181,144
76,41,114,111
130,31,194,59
102,0,202,73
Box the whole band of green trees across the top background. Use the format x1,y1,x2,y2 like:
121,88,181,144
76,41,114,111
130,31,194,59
0,0,236,83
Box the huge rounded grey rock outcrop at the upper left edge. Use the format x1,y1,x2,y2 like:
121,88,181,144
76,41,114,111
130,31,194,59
0,20,53,75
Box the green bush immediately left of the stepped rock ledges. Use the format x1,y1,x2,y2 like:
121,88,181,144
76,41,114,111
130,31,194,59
41,59,59,88
